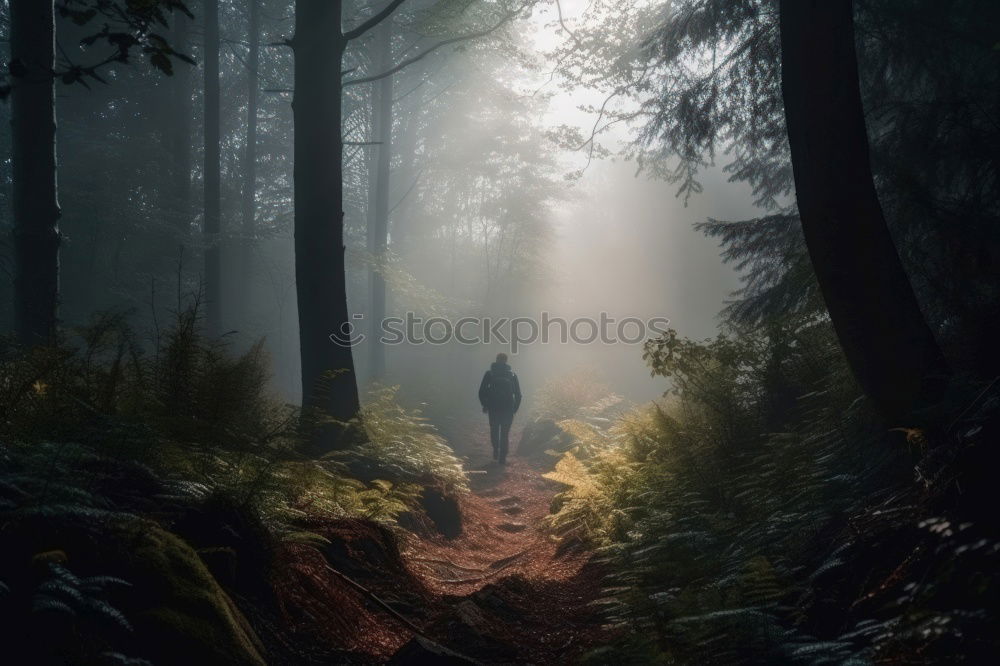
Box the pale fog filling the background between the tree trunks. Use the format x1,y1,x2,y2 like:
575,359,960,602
0,0,755,420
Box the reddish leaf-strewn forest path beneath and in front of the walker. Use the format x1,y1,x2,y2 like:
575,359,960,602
332,424,606,664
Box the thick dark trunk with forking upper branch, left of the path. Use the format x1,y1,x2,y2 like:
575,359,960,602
292,0,360,449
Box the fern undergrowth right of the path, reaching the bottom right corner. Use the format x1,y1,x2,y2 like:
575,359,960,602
546,321,1000,664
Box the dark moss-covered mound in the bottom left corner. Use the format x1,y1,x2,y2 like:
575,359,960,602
0,516,265,666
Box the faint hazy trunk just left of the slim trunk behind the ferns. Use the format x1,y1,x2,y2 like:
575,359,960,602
168,5,193,245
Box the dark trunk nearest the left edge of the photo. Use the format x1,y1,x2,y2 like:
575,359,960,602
10,0,60,345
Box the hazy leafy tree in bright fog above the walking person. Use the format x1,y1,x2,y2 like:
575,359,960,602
406,67,567,312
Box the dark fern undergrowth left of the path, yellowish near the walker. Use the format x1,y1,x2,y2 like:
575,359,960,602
0,305,466,663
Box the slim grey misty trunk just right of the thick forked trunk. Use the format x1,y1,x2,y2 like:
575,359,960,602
368,20,393,379
